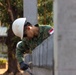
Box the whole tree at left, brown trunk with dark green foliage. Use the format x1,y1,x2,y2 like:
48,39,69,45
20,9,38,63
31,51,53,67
0,0,23,75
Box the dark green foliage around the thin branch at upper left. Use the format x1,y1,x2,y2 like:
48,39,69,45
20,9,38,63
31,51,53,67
0,0,23,26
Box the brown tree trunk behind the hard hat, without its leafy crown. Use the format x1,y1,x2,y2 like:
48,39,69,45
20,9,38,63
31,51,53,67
3,26,19,75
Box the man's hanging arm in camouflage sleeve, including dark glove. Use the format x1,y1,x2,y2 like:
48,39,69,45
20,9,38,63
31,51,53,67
16,41,29,70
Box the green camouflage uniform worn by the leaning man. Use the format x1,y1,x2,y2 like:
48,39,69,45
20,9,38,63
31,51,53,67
16,26,51,63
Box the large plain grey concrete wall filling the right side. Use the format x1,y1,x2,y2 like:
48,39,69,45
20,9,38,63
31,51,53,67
54,0,76,75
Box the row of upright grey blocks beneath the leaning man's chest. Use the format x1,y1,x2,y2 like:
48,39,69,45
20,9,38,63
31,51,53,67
32,35,54,68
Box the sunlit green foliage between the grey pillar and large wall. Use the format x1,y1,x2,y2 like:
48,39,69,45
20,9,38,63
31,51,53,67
38,0,53,26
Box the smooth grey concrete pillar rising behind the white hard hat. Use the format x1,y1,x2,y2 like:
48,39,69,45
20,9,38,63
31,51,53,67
23,0,38,25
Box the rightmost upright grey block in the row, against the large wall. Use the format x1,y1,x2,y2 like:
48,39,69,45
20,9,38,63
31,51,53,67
47,35,54,68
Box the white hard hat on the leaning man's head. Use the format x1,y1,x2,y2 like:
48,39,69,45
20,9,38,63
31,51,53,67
12,18,27,39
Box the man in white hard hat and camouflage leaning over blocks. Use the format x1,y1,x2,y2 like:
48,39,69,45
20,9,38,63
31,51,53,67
12,18,53,70
